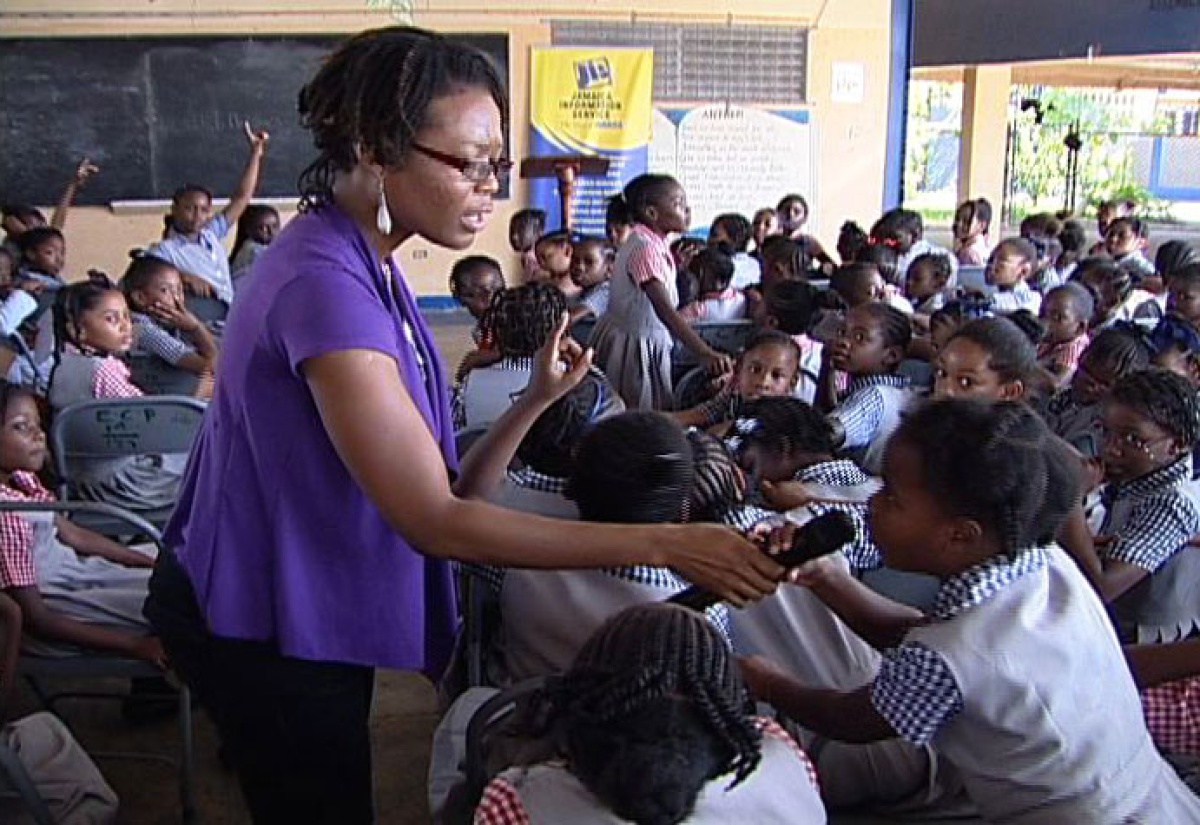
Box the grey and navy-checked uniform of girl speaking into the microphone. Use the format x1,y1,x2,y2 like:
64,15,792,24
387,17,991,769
870,546,1200,825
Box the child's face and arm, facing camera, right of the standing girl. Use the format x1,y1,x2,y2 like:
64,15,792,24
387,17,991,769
671,330,800,435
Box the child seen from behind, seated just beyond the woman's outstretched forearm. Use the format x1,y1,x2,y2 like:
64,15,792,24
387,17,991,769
500,413,727,681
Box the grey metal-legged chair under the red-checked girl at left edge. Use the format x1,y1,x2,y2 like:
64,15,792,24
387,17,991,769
0,501,196,821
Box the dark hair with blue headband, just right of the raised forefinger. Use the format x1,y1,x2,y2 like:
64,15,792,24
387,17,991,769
517,367,625,478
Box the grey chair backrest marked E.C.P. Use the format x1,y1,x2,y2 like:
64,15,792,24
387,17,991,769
50,396,205,481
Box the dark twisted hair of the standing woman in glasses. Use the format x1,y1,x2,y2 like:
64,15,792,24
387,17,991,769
298,26,509,210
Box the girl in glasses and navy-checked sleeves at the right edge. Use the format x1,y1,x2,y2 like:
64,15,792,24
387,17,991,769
1080,369,1200,643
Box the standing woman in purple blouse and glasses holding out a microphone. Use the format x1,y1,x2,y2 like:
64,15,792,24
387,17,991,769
146,28,782,823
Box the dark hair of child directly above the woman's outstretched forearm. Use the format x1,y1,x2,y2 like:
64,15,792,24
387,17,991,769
566,413,696,524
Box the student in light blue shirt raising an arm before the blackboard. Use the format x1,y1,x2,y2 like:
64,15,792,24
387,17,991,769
149,122,269,303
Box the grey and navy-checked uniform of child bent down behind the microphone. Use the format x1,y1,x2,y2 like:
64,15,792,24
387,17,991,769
731,460,882,691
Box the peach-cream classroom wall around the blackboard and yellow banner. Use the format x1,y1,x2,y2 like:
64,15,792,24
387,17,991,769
0,0,890,295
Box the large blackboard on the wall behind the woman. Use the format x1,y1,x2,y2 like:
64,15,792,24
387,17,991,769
0,34,509,205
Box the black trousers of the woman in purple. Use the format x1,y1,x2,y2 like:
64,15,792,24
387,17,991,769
145,553,374,825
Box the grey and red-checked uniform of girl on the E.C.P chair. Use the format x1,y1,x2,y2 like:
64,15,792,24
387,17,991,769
49,351,187,511
